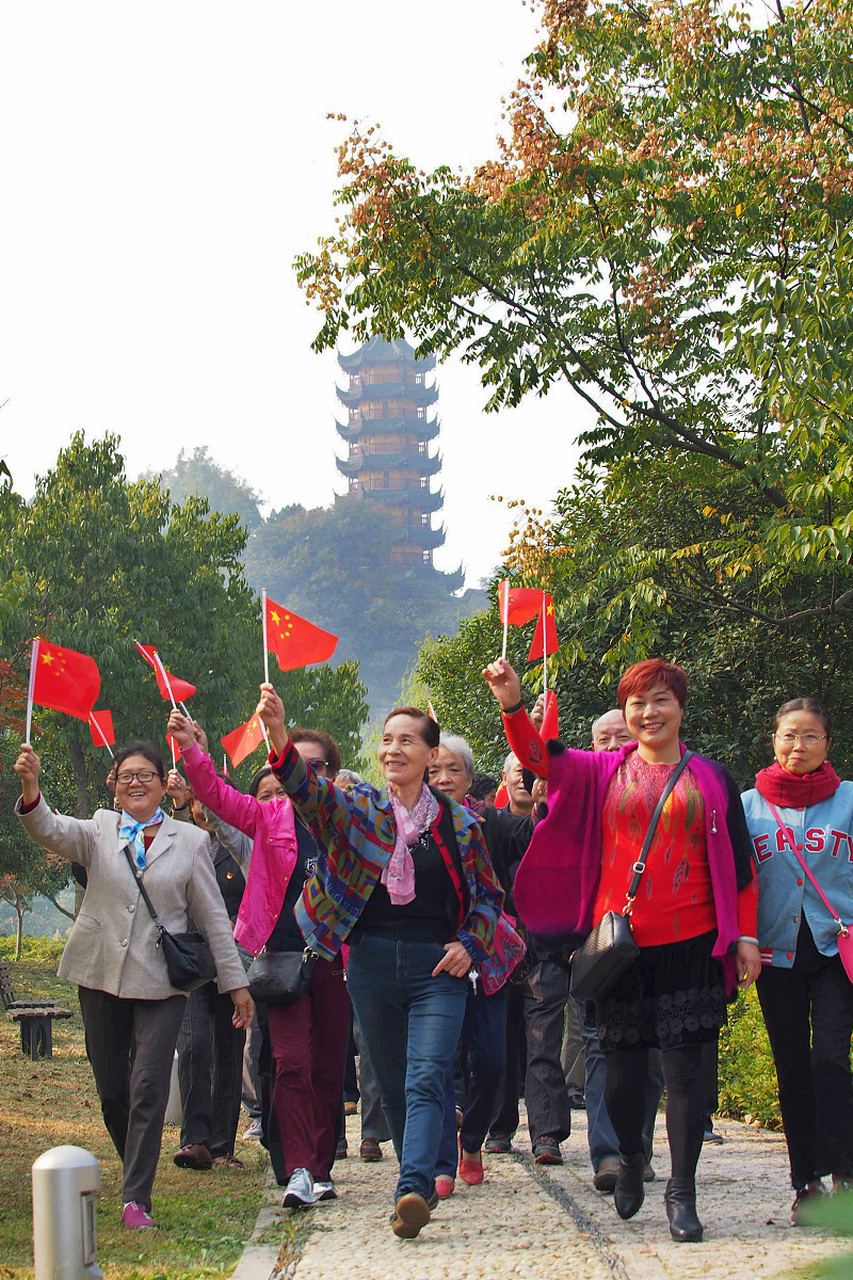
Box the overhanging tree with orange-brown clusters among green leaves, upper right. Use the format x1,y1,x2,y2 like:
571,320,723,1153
297,0,853,629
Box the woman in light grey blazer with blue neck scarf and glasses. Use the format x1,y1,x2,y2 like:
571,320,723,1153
15,742,252,1230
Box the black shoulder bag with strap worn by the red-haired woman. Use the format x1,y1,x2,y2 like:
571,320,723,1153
563,751,693,1000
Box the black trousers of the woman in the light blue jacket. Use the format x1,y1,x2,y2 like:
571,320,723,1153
756,920,853,1190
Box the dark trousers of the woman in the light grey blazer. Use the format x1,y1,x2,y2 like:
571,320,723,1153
79,987,187,1210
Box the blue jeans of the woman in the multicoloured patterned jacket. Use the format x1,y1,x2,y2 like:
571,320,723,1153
347,933,469,1199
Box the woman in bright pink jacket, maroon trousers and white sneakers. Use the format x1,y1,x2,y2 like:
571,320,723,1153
169,712,350,1208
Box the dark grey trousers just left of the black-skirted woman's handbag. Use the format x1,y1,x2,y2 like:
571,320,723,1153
523,960,571,1142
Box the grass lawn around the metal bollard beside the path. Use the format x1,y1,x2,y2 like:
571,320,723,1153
0,940,268,1280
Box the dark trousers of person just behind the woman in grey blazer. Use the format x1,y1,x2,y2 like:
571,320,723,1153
178,982,246,1156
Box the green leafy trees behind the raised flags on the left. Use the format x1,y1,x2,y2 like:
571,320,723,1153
0,434,365,815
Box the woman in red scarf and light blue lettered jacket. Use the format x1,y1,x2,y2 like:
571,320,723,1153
743,698,853,1224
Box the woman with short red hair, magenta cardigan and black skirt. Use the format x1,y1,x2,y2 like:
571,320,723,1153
484,658,761,1242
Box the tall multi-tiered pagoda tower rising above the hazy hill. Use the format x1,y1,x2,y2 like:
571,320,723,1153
336,338,450,573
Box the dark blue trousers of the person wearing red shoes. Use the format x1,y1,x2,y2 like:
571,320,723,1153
435,983,506,1178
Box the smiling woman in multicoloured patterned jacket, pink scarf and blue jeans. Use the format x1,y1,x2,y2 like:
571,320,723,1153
257,685,523,1239
